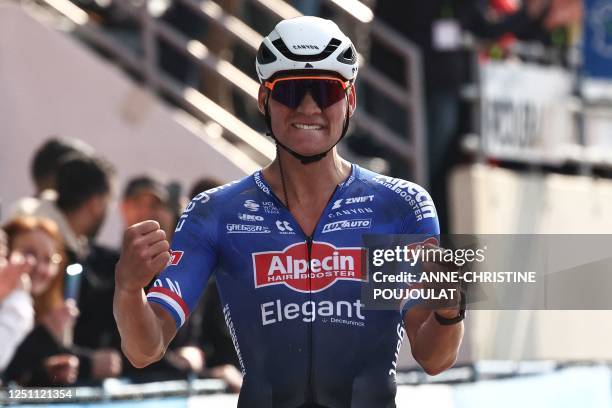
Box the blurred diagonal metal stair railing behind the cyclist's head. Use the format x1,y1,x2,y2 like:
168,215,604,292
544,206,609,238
34,0,427,185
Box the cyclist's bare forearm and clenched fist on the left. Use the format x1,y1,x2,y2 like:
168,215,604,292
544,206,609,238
113,221,176,368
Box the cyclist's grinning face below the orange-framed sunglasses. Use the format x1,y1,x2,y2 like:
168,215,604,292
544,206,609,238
259,77,356,156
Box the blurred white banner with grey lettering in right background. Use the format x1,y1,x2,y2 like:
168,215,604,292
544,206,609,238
481,62,577,163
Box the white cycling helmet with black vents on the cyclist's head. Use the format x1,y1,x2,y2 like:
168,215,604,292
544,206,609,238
255,16,358,83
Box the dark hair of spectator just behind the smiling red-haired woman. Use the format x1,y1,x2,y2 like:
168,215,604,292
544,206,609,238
57,153,114,212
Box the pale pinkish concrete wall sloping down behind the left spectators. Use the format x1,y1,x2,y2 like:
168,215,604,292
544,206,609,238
0,5,256,249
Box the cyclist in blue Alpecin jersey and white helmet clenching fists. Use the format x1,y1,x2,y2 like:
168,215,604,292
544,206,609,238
114,17,463,408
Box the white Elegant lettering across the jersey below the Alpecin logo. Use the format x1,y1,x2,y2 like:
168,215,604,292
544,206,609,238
261,299,365,327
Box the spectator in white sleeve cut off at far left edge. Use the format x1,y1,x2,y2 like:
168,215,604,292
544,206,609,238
0,229,34,374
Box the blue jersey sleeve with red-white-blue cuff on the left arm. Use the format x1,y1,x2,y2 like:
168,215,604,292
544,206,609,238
147,193,217,329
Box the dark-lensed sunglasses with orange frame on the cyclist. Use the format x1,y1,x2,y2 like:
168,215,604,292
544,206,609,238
264,76,350,109
